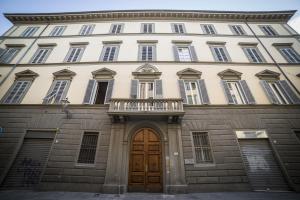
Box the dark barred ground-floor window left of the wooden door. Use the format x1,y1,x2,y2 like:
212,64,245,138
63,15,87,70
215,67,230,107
77,132,99,164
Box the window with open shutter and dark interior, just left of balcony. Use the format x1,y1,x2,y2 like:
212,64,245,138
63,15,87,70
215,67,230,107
83,79,114,104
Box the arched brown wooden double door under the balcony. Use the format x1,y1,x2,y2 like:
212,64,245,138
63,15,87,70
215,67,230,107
128,128,163,192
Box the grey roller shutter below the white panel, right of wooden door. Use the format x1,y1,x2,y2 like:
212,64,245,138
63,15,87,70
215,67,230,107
239,139,289,191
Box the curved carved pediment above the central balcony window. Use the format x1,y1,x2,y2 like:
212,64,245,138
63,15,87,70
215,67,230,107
132,63,161,79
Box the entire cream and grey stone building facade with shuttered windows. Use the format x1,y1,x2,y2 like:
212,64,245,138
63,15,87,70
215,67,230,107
0,10,300,193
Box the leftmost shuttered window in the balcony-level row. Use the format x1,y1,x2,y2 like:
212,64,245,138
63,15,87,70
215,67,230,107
2,80,31,104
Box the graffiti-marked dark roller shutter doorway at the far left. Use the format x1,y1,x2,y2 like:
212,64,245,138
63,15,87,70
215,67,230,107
3,132,55,189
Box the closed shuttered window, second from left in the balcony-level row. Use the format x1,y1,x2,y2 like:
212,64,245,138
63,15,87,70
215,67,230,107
43,80,70,104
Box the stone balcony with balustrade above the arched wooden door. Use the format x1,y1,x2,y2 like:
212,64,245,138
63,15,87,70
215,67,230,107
108,98,184,123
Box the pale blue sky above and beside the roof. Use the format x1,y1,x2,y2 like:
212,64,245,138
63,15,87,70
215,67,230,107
0,0,300,35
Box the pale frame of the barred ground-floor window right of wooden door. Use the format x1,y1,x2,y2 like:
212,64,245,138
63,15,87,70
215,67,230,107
190,131,214,164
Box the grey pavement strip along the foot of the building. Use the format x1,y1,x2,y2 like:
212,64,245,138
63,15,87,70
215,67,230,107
0,190,300,200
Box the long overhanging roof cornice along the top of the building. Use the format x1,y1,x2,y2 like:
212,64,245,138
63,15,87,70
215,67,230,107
4,10,296,24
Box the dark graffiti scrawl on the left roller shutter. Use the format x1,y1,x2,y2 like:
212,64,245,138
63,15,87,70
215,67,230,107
18,157,42,186
